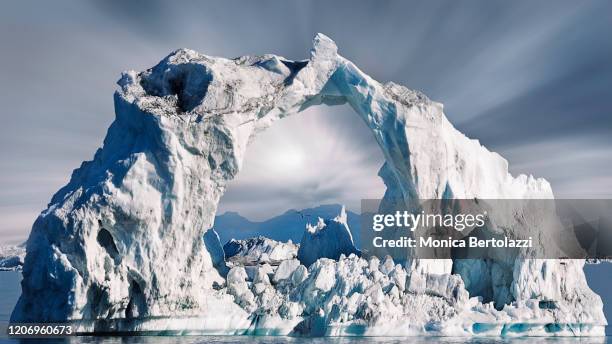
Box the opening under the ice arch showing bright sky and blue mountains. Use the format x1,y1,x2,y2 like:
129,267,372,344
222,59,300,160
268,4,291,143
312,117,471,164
213,103,385,245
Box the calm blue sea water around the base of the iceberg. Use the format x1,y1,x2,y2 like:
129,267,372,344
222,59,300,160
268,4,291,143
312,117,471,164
0,264,612,344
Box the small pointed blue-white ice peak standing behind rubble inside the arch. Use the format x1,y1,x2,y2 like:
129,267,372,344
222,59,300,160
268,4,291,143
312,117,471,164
298,207,359,266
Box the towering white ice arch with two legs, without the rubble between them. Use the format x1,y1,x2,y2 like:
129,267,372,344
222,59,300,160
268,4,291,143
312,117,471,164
12,34,605,332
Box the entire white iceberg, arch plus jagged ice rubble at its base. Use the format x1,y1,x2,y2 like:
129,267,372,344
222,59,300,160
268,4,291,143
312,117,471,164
12,35,605,335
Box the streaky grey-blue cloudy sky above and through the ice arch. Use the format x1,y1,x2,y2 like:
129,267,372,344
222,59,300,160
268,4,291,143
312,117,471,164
0,0,612,243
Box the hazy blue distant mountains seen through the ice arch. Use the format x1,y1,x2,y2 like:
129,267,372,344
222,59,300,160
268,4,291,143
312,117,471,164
213,204,360,247
